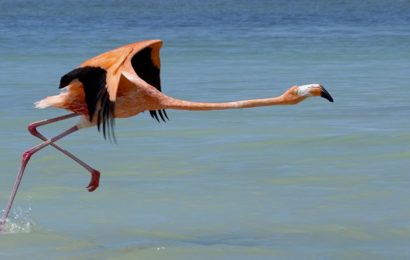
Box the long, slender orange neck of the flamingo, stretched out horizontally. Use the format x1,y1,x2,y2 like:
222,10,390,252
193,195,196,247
163,96,288,110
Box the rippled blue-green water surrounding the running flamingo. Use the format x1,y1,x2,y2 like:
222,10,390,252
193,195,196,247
0,0,410,259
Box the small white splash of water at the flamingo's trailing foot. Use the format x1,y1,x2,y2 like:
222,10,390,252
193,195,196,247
0,207,34,234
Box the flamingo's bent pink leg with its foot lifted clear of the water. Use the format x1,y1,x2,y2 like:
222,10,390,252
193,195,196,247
28,113,100,192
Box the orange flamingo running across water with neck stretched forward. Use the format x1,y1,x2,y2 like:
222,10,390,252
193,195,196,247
0,40,333,227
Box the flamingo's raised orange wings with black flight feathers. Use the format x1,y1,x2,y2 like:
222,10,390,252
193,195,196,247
60,40,168,141
